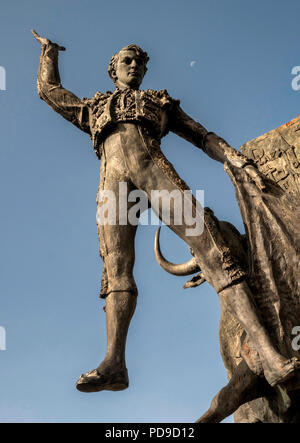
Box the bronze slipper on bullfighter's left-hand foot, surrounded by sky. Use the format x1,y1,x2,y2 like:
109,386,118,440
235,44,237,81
76,369,129,392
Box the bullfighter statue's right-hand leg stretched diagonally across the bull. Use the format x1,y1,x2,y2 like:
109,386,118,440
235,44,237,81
135,145,299,386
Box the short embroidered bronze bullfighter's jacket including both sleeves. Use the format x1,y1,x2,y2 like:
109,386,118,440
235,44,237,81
37,43,251,167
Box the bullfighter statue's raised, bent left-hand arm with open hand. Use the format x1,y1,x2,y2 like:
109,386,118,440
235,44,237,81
32,31,90,134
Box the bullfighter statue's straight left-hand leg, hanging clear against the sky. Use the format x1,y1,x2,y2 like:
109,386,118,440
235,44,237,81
76,149,137,392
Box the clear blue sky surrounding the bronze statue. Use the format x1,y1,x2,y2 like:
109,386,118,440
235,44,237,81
0,0,300,422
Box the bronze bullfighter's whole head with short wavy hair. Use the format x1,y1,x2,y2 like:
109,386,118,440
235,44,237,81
108,45,149,89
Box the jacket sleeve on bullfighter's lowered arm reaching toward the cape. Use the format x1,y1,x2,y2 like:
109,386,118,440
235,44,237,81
169,101,252,167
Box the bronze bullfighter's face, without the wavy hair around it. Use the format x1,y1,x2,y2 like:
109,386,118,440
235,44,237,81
115,50,145,89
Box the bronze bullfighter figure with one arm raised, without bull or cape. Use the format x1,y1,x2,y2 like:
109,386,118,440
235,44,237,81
33,31,300,400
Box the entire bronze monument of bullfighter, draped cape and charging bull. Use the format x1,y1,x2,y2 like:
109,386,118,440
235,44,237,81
33,31,300,422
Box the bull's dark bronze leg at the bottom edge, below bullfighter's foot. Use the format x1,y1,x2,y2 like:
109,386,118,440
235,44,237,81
196,361,271,423
